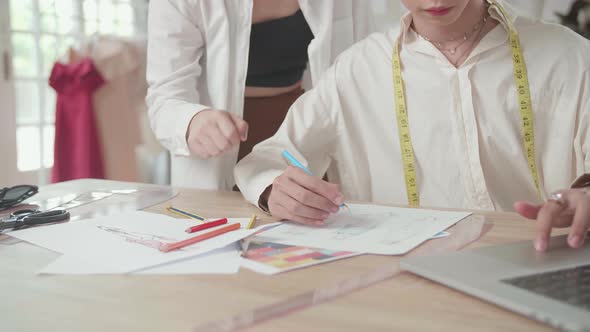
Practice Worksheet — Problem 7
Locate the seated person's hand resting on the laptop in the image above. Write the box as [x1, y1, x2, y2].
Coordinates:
[514, 188, 590, 251]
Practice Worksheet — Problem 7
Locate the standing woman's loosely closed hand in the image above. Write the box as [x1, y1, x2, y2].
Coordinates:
[186, 109, 248, 159]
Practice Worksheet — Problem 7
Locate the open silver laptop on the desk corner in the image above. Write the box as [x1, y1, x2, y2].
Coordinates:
[401, 236, 590, 331]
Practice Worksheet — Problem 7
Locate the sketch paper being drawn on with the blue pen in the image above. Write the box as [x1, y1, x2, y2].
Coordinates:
[257, 204, 470, 255]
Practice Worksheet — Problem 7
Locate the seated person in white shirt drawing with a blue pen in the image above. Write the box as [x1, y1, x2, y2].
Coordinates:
[235, 0, 590, 250]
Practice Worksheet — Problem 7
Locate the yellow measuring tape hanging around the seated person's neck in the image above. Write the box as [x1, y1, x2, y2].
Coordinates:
[392, 1, 542, 207]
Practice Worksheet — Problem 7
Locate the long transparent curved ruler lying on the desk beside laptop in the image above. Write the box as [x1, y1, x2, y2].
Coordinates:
[193, 216, 491, 332]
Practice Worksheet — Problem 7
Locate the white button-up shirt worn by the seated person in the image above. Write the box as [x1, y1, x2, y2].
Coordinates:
[235, 2, 590, 210]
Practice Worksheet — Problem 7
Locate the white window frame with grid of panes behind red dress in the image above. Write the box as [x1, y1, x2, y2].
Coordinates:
[0, 0, 148, 184]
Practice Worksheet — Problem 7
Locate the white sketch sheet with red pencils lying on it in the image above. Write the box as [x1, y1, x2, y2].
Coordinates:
[8, 211, 266, 273]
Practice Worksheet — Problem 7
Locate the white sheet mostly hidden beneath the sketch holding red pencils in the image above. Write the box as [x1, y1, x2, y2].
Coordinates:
[39, 244, 241, 275]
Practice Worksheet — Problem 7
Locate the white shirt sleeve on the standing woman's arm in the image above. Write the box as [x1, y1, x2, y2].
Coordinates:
[146, 0, 210, 156]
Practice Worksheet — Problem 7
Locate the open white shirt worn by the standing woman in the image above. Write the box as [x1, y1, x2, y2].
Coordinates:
[146, 0, 382, 190]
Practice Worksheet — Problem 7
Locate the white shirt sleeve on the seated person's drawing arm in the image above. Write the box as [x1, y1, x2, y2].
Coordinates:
[234, 66, 341, 206]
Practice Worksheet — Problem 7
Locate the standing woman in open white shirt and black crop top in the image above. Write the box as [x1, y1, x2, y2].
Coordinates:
[147, 0, 380, 190]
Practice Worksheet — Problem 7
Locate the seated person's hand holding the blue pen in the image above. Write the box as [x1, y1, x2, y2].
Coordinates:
[266, 166, 344, 225]
